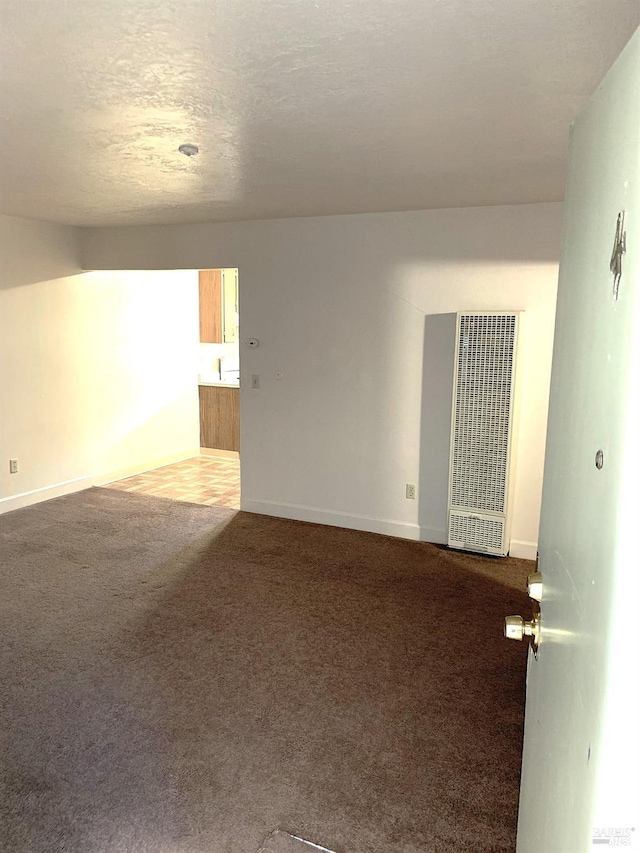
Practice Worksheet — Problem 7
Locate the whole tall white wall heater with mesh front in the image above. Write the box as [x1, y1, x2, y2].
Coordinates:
[448, 311, 519, 555]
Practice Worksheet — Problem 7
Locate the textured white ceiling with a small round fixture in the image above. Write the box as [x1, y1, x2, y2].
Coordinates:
[0, 0, 640, 225]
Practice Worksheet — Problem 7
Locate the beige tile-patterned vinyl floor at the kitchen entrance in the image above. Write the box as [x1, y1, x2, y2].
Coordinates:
[104, 456, 240, 509]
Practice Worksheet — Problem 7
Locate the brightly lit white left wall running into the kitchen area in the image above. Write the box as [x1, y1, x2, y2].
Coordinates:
[0, 216, 199, 512]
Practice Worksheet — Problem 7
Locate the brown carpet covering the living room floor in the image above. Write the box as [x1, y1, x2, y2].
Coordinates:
[0, 489, 531, 853]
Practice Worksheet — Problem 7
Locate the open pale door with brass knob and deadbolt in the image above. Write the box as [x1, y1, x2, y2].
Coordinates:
[512, 26, 640, 853]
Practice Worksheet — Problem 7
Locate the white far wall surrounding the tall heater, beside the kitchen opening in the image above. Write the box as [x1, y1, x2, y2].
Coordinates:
[83, 204, 561, 558]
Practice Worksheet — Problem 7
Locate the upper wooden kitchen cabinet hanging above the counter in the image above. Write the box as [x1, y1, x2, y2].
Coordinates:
[198, 269, 238, 344]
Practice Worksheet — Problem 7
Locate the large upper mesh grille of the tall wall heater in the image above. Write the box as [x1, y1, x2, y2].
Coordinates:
[451, 314, 516, 512]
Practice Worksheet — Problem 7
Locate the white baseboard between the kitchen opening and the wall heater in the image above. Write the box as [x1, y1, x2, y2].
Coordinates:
[240, 497, 446, 544]
